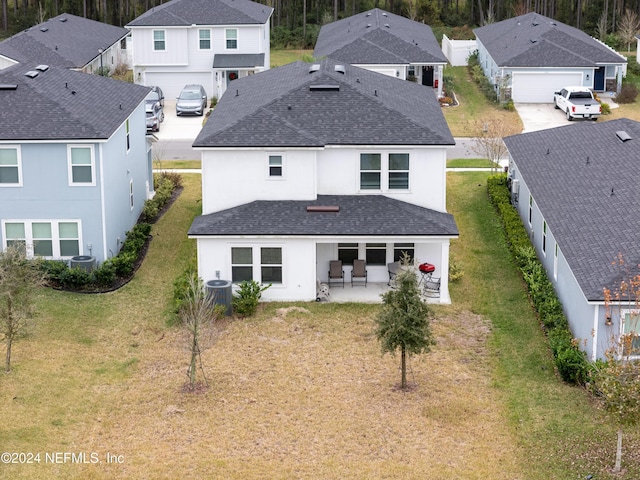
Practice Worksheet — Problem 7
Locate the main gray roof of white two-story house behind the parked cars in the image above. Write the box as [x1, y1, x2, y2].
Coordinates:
[127, 0, 273, 27]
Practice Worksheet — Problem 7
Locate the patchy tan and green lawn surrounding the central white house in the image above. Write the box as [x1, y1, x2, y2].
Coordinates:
[0, 173, 640, 480]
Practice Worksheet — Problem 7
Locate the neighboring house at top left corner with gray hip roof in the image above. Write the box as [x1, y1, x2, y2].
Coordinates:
[0, 13, 129, 73]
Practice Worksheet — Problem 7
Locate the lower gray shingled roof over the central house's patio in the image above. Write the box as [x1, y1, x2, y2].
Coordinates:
[189, 195, 458, 237]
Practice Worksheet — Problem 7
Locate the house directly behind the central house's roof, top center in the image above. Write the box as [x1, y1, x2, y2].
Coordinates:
[313, 8, 447, 97]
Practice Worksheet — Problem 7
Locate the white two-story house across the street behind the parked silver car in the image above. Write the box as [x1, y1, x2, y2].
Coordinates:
[126, 0, 273, 98]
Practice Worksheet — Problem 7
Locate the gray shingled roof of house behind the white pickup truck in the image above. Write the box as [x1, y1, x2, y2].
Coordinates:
[474, 13, 627, 67]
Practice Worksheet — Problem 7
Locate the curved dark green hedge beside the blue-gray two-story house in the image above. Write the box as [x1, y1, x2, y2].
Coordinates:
[41, 173, 182, 293]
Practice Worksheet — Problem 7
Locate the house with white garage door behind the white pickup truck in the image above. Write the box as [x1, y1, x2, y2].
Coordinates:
[474, 13, 627, 103]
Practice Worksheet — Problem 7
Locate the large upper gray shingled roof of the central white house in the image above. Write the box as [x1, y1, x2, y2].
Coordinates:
[193, 60, 455, 147]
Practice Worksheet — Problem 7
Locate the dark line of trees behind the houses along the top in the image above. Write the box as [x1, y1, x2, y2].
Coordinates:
[0, 0, 640, 48]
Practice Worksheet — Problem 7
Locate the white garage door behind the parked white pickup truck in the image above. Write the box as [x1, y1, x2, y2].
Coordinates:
[511, 72, 582, 103]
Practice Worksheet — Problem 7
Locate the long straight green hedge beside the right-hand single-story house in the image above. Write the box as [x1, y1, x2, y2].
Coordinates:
[487, 174, 590, 385]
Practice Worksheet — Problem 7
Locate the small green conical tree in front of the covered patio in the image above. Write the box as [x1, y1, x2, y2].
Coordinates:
[375, 262, 435, 389]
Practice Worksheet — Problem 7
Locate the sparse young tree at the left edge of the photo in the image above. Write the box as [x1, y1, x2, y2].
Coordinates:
[0, 246, 44, 373]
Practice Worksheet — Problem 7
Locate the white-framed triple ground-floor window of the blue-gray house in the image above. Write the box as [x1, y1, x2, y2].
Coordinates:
[2, 220, 80, 258]
